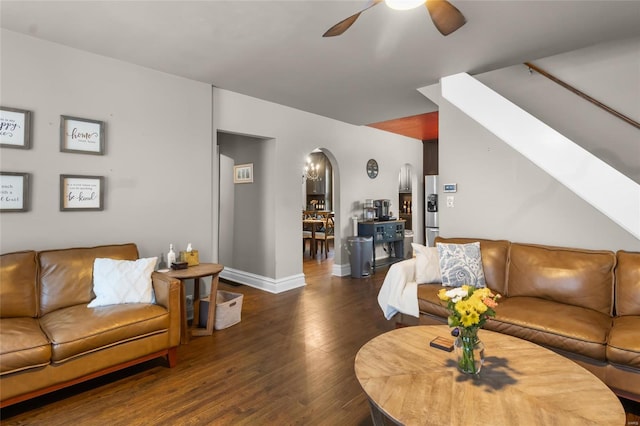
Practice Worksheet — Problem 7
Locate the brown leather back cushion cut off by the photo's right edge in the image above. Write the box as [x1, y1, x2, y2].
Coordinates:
[616, 250, 640, 315]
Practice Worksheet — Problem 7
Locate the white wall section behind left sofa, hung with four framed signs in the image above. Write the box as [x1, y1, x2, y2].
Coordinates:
[0, 30, 212, 261]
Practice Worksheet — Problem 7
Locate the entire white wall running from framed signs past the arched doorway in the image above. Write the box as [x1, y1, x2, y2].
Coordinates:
[0, 30, 423, 288]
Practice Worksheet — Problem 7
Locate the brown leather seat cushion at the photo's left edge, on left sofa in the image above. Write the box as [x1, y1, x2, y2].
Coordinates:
[0, 317, 51, 375]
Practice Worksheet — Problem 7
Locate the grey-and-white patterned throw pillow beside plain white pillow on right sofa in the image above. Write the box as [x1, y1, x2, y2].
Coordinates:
[436, 242, 486, 288]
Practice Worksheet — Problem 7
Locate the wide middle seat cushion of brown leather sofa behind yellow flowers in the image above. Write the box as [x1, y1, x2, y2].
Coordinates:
[485, 297, 611, 361]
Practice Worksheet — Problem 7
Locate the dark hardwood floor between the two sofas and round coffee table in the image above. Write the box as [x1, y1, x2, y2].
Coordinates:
[1, 251, 640, 426]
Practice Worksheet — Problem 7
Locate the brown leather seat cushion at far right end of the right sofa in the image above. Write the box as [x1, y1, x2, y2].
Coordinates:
[607, 316, 640, 369]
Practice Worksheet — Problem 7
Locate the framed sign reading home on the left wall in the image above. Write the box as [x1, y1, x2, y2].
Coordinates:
[60, 115, 105, 155]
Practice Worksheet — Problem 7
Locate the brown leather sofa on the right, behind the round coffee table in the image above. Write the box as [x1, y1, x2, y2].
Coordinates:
[410, 237, 640, 401]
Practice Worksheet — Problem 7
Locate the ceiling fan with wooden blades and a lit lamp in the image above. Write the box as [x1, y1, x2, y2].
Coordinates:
[322, 0, 467, 37]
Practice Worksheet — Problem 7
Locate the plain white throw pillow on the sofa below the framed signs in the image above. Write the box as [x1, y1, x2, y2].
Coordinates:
[87, 257, 158, 308]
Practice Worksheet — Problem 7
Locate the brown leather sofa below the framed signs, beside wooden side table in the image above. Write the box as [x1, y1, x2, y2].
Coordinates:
[0, 244, 181, 407]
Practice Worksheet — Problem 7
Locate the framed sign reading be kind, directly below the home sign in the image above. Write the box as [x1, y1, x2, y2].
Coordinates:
[60, 175, 104, 211]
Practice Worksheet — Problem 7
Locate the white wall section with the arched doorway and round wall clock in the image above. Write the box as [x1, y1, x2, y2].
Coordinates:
[214, 89, 423, 285]
